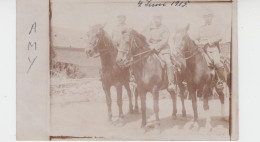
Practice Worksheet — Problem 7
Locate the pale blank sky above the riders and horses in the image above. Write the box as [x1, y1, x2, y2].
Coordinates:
[51, 0, 232, 48]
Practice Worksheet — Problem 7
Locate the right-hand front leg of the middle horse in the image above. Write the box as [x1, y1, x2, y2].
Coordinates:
[153, 87, 160, 128]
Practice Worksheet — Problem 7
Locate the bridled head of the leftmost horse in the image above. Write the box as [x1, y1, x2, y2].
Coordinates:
[85, 24, 105, 57]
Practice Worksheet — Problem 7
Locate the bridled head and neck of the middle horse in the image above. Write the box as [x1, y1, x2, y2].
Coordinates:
[116, 29, 149, 66]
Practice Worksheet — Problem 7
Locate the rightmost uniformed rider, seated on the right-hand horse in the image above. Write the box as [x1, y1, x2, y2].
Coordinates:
[195, 11, 226, 89]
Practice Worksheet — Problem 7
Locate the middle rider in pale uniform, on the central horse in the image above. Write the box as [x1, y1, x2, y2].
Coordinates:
[144, 15, 176, 91]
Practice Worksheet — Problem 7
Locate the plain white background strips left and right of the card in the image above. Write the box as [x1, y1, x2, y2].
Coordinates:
[0, 0, 260, 142]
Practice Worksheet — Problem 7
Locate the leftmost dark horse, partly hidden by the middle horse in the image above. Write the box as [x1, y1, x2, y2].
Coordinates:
[85, 24, 138, 121]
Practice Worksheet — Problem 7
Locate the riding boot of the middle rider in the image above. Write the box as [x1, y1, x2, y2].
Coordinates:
[167, 66, 177, 92]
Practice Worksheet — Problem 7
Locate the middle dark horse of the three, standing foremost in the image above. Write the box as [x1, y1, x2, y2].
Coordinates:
[117, 30, 186, 130]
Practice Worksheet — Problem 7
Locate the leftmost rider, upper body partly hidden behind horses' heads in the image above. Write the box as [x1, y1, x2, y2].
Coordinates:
[112, 15, 129, 48]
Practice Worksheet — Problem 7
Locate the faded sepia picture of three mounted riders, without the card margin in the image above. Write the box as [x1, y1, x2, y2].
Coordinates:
[49, 0, 234, 140]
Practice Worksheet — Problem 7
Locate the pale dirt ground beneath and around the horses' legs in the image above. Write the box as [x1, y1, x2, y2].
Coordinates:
[50, 78, 229, 140]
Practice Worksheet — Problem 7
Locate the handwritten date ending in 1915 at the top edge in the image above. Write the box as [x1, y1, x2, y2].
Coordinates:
[137, 0, 190, 7]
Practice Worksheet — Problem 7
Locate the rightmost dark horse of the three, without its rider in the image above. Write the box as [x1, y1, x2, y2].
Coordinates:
[174, 25, 231, 129]
